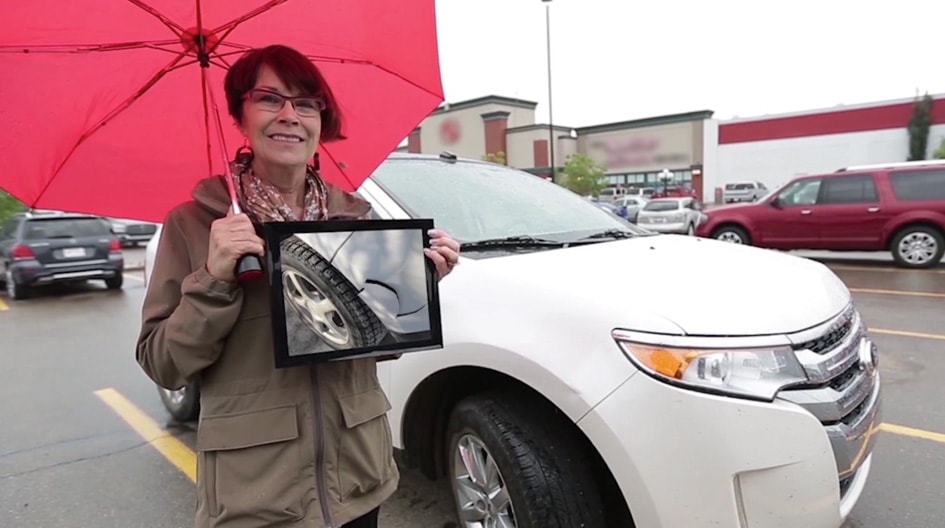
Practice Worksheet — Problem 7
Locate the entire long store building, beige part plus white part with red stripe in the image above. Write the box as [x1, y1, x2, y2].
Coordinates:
[401, 94, 945, 202]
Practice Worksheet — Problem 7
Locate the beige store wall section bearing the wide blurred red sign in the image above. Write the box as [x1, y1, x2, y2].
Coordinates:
[578, 122, 702, 173]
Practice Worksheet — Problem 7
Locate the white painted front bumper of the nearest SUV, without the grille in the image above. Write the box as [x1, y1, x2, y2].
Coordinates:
[580, 374, 871, 528]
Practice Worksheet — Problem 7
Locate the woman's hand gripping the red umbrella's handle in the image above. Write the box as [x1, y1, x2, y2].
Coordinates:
[207, 211, 265, 282]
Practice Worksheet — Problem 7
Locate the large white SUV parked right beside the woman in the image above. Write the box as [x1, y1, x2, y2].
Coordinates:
[147, 153, 881, 528]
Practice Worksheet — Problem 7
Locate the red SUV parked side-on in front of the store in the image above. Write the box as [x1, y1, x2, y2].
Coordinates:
[696, 160, 945, 268]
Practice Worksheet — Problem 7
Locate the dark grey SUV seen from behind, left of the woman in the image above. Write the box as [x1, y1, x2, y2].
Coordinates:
[0, 211, 125, 300]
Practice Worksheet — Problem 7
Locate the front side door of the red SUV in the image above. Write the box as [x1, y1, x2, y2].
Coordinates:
[752, 178, 822, 250]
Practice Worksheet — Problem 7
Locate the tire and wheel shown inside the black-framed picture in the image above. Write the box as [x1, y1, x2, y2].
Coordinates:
[281, 237, 387, 350]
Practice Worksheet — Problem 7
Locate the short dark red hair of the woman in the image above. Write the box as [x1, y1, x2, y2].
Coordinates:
[223, 44, 344, 142]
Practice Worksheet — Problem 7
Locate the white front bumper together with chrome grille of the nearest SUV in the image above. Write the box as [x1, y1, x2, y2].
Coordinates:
[579, 307, 882, 528]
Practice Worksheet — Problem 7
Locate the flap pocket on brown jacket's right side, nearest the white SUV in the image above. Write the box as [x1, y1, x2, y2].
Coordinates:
[338, 387, 393, 502]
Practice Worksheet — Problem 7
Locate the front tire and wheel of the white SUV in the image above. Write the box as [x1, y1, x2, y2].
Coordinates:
[446, 390, 607, 528]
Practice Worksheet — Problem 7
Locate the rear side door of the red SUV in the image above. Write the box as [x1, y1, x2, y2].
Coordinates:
[811, 174, 892, 250]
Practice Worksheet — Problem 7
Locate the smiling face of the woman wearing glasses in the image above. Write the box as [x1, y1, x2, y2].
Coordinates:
[240, 64, 323, 168]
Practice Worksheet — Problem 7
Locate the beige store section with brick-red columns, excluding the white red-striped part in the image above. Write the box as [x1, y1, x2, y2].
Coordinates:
[401, 95, 717, 200]
